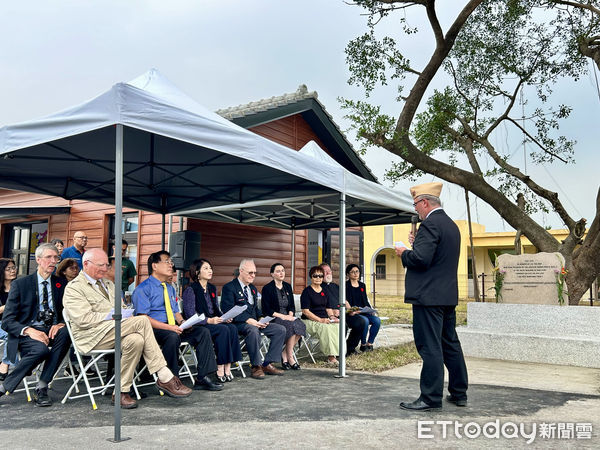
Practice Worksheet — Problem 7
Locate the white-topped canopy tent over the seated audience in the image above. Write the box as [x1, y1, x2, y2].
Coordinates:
[0, 70, 412, 440]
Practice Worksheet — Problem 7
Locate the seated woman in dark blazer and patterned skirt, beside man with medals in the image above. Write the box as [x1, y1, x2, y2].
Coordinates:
[261, 263, 306, 370]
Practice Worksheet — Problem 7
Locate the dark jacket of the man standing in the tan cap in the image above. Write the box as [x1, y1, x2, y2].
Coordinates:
[402, 209, 460, 306]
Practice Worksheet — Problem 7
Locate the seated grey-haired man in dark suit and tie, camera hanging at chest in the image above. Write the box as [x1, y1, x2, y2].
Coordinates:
[0, 244, 71, 406]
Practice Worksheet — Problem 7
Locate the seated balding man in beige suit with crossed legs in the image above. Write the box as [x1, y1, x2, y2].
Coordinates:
[63, 248, 192, 409]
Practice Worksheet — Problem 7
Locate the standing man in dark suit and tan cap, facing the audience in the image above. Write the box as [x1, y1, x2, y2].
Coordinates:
[396, 183, 468, 411]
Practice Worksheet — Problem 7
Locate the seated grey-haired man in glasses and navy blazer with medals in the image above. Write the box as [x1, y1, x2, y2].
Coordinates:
[221, 259, 285, 380]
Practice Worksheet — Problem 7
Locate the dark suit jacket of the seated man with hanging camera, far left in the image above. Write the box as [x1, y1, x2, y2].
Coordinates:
[2, 272, 67, 361]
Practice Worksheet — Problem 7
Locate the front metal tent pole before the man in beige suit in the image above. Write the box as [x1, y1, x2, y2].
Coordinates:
[109, 124, 127, 442]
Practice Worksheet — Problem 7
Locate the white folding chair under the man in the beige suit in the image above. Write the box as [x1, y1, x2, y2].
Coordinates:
[61, 310, 116, 410]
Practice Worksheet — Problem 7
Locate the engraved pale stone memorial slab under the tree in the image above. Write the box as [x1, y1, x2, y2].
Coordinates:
[495, 253, 569, 305]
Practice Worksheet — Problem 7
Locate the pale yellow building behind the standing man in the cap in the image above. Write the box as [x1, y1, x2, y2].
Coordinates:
[363, 220, 568, 299]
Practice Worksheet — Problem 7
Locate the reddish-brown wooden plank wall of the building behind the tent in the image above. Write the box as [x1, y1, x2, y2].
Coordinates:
[0, 114, 340, 293]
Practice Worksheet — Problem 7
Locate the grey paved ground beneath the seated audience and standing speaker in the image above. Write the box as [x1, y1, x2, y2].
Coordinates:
[0, 330, 600, 449]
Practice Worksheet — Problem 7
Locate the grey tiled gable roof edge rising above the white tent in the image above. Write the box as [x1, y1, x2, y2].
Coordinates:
[216, 84, 377, 180]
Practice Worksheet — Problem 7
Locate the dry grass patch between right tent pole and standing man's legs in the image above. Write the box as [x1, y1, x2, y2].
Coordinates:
[302, 342, 421, 373]
